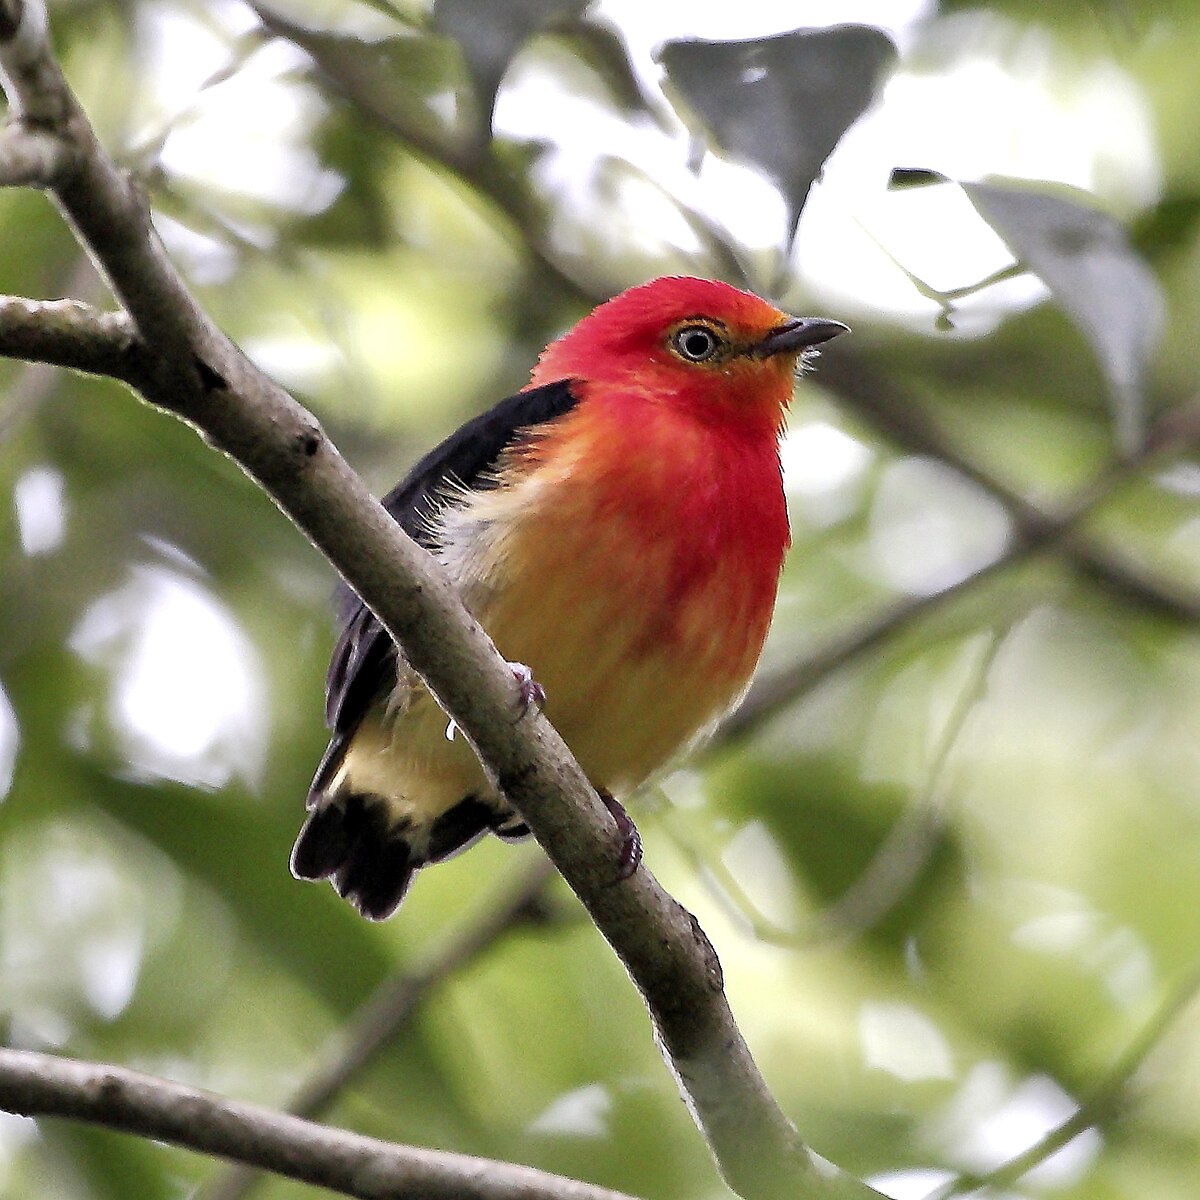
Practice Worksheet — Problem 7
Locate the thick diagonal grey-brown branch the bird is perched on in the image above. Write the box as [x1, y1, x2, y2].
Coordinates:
[0, 0, 876, 1198]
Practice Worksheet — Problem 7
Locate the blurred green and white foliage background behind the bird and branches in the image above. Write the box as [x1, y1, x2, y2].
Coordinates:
[0, 0, 1200, 1200]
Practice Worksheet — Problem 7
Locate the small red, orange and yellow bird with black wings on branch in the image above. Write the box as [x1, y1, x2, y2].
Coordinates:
[290, 276, 847, 920]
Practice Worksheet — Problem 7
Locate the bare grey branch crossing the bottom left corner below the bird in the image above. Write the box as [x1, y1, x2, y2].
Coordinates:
[0, 1049, 631, 1200]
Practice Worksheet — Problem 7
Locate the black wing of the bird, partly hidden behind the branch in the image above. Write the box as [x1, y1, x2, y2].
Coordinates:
[313, 379, 577, 748]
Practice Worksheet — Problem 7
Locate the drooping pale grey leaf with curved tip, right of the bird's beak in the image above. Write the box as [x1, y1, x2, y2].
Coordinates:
[962, 182, 1163, 452]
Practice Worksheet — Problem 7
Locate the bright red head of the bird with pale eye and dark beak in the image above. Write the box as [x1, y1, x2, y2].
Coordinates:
[533, 276, 846, 428]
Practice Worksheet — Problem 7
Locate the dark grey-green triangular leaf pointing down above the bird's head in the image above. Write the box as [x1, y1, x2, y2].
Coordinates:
[659, 25, 895, 238]
